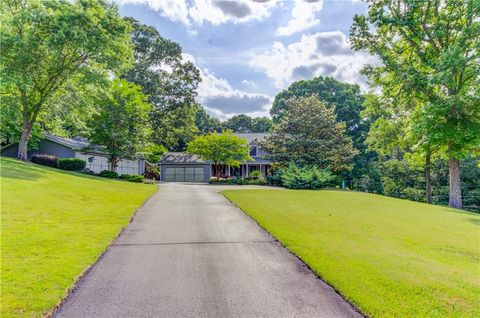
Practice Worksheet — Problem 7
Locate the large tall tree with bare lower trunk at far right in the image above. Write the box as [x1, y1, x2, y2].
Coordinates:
[351, 0, 480, 208]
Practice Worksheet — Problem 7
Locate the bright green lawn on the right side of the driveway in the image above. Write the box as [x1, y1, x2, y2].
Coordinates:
[223, 190, 480, 317]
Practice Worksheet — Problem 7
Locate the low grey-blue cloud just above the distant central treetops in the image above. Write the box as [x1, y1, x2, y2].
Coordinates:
[183, 53, 273, 119]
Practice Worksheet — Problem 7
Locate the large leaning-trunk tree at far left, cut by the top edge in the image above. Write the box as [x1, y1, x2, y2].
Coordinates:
[0, 0, 131, 160]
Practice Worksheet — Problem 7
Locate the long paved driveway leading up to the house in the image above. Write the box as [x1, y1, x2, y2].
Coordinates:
[55, 183, 362, 318]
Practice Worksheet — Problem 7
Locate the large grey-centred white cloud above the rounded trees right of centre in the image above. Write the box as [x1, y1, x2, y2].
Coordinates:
[250, 31, 374, 88]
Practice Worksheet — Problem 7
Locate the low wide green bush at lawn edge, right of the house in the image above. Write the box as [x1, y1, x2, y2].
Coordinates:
[279, 163, 336, 189]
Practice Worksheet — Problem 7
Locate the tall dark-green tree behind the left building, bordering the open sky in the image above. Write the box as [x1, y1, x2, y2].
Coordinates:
[124, 18, 201, 150]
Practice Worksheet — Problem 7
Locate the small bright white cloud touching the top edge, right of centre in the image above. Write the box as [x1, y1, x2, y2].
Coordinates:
[277, 0, 323, 35]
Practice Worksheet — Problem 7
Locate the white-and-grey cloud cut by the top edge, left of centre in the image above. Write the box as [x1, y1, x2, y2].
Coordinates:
[114, 0, 277, 27]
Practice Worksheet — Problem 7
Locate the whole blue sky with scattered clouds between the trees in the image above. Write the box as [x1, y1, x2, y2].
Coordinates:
[114, 0, 373, 119]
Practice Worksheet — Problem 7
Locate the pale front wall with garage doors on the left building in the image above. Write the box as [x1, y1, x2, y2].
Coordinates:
[75, 152, 145, 174]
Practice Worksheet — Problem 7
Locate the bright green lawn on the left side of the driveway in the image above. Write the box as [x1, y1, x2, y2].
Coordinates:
[0, 158, 157, 317]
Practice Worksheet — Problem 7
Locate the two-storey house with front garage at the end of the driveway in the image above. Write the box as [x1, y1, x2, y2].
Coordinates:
[159, 133, 270, 182]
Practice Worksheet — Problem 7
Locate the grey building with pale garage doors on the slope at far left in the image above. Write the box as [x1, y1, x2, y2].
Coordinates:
[1, 133, 145, 175]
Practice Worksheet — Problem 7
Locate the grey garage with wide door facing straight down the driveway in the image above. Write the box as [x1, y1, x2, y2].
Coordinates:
[159, 152, 211, 183]
